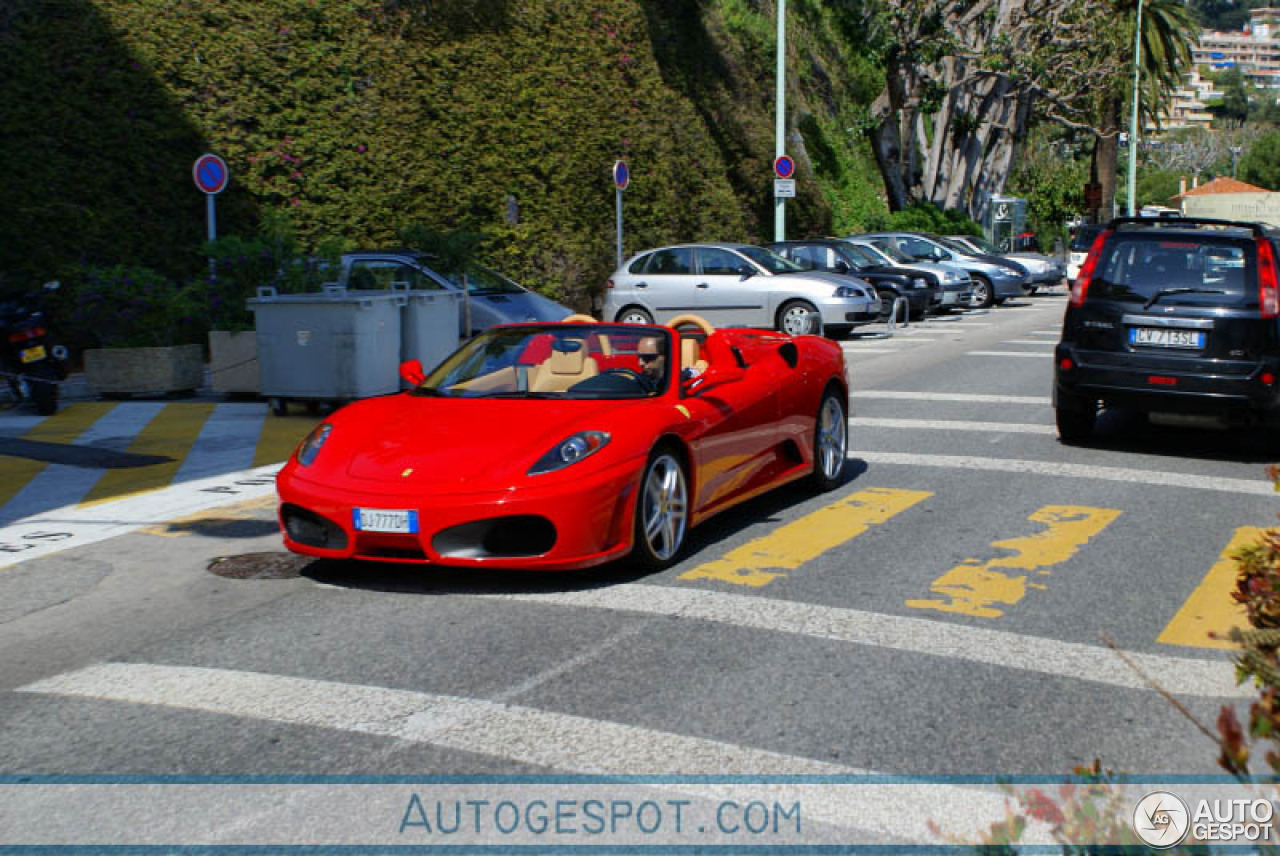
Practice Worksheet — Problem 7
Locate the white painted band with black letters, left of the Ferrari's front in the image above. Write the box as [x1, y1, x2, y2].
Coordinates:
[0, 464, 279, 568]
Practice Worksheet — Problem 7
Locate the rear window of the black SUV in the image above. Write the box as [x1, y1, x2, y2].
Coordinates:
[1088, 232, 1257, 306]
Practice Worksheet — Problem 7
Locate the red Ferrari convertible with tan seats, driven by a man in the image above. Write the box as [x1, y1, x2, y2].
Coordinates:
[276, 315, 849, 571]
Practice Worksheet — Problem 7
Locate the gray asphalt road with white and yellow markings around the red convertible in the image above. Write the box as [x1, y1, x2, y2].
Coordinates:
[0, 294, 1275, 839]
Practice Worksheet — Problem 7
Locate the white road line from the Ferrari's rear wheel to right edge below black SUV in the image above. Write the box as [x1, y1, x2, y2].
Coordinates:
[849, 449, 1276, 496]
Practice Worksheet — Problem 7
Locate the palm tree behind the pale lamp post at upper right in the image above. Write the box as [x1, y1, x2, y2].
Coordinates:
[1091, 0, 1199, 220]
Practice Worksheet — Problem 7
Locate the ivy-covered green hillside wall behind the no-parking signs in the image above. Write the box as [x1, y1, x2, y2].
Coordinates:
[0, 0, 884, 307]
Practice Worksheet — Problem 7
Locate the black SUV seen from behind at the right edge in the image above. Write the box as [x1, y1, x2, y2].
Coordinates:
[1053, 218, 1280, 443]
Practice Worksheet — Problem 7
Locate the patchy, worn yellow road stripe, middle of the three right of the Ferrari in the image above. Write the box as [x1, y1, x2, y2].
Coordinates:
[906, 505, 1120, 618]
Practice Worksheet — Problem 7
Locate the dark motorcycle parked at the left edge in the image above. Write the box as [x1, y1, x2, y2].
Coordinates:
[0, 281, 67, 416]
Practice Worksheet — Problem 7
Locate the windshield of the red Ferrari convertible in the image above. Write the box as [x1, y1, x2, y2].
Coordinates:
[412, 324, 671, 399]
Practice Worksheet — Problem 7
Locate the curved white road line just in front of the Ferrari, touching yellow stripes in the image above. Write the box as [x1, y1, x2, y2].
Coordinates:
[491, 583, 1256, 699]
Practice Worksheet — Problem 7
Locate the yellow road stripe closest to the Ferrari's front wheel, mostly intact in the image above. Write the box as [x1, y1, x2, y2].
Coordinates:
[680, 487, 933, 587]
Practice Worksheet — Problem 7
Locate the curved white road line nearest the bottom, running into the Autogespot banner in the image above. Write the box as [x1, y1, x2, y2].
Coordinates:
[18, 663, 1052, 850]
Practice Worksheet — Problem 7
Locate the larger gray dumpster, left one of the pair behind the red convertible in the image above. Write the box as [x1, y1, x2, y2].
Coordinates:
[248, 287, 406, 416]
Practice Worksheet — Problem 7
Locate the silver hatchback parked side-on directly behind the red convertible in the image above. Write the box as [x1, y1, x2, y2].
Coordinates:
[602, 243, 881, 337]
